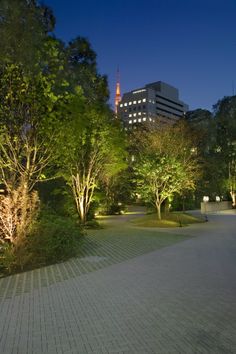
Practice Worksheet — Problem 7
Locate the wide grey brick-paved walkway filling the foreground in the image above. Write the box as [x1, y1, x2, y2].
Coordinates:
[0, 213, 236, 354]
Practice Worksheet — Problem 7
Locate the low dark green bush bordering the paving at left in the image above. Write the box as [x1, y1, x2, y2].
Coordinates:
[0, 213, 83, 274]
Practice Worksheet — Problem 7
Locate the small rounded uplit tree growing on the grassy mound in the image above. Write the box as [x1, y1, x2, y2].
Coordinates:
[134, 122, 199, 219]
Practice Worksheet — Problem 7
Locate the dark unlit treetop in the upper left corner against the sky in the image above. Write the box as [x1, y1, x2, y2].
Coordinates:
[0, 0, 55, 71]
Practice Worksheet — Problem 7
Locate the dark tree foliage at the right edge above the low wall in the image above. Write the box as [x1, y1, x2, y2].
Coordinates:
[198, 96, 236, 202]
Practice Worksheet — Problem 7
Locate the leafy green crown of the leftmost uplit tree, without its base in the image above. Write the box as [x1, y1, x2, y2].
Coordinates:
[0, 64, 63, 196]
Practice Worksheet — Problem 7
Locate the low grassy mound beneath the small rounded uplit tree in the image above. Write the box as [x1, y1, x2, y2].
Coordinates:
[131, 212, 204, 228]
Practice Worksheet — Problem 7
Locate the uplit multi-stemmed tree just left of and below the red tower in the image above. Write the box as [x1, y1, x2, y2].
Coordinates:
[58, 90, 125, 224]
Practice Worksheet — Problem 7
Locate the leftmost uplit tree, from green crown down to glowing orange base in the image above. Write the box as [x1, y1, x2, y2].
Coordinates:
[0, 64, 62, 243]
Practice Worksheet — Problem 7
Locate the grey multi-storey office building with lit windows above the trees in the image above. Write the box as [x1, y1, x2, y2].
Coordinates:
[117, 81, 188, 127]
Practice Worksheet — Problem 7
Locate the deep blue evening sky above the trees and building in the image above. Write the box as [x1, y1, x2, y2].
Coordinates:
[44, 0, 236, 110]
